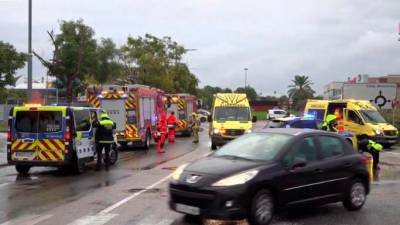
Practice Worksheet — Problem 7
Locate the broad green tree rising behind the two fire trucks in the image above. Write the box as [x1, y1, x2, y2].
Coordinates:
[119, 34, 199, 94]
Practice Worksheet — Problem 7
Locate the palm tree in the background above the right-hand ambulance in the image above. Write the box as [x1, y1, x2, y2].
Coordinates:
[287, 75, 315, 98]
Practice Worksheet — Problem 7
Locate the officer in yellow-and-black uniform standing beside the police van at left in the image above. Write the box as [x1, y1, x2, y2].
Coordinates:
[94, 113, 116, 171]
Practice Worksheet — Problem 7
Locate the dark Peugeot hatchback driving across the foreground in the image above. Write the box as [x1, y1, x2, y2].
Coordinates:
[169, 128, 370, 225]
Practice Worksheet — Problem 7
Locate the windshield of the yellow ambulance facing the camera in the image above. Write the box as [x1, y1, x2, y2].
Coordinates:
[215, 107, 250, 121]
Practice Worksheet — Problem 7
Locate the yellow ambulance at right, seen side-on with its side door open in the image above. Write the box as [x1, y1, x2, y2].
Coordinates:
[304, 99, 398, 147]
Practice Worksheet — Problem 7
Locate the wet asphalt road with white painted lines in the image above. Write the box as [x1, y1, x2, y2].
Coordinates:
[0, 124, 400, 225]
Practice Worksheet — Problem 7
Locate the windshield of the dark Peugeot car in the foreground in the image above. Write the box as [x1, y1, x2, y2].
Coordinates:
[214, 133, 291, 161]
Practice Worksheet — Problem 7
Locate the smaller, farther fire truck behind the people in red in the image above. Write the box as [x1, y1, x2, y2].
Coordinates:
[164, 93, 197, 136]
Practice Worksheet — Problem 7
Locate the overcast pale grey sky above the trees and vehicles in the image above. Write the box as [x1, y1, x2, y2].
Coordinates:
[0, 0, 400, 95]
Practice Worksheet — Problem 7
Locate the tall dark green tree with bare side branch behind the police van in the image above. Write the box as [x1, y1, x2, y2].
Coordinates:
[34, 20, 98, 102]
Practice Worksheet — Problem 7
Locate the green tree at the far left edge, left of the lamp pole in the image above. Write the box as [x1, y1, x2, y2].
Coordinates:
[0, 41, 26, 93]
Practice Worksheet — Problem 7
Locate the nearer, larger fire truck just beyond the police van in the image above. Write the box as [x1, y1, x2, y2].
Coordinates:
[86, 85, 165, 149]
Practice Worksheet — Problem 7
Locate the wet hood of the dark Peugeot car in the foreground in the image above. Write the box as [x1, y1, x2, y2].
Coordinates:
[185, 156, 262, 176]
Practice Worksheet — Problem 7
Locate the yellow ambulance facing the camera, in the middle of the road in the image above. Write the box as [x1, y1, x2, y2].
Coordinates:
[208, 93, 257, 150]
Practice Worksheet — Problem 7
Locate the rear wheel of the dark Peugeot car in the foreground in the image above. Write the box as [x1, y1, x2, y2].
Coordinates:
[343, 179, 367, 211]
